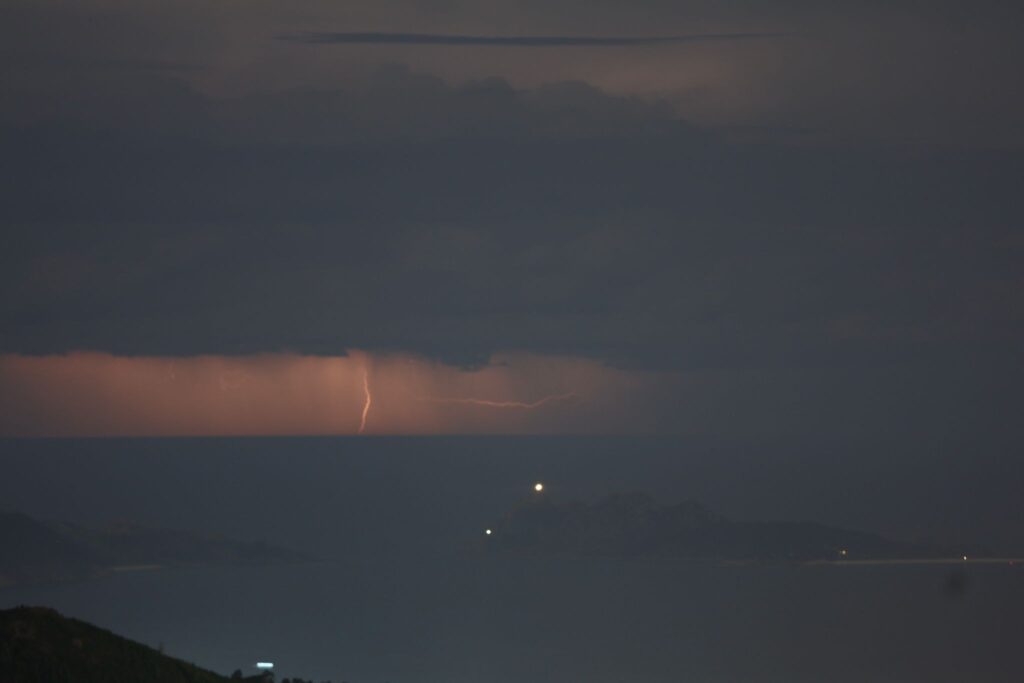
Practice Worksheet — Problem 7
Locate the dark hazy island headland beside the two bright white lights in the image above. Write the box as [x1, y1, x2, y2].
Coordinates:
[486, 494, 974, 561]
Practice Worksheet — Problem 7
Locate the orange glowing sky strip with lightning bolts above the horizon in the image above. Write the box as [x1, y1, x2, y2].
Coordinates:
[0, 351, 646, 436]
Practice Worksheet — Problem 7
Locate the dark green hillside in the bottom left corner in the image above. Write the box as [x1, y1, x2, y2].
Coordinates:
[0, 607, 246, 683]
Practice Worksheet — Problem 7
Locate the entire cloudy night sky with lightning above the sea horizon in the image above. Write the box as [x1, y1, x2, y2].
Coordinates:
[0, 0, 1024, 438]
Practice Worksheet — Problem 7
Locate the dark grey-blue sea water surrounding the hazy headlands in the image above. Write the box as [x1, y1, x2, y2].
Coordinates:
[0, 437, 1024, 683]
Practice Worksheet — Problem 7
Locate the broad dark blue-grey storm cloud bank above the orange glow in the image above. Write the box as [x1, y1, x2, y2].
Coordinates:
[3, 69, 1021, 367]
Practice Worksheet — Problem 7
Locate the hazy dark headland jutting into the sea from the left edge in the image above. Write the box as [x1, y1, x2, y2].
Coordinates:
[0, 512, 309, 587]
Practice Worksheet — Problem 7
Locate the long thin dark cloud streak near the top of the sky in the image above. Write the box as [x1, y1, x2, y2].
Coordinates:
[279, 31, 783, 47]
